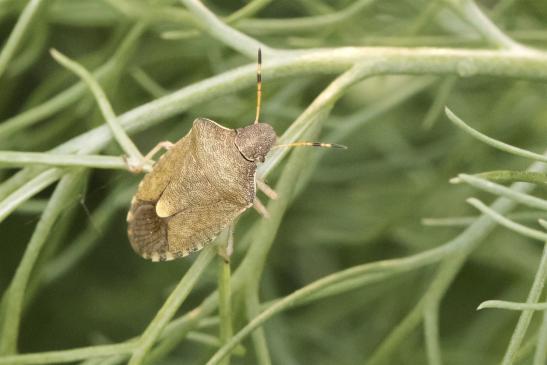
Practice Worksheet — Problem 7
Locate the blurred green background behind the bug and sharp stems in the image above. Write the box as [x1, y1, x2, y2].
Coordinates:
[0, 0, 547, 365]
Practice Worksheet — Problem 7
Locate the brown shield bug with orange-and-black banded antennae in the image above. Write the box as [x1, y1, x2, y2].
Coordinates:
[127, 49, 344, 261]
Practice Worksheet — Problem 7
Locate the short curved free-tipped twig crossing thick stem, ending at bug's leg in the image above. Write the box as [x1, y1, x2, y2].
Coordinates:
[51, 49, 145, 166]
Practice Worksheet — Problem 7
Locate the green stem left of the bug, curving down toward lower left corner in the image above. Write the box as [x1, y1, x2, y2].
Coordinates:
[0, 172, 83, 355]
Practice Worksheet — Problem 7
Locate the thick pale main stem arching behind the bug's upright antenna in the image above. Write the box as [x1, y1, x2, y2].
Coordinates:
[48, 47, 547, 161]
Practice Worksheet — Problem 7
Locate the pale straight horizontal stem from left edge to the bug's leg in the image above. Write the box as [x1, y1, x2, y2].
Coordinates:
[0, 151, 128, 171]
